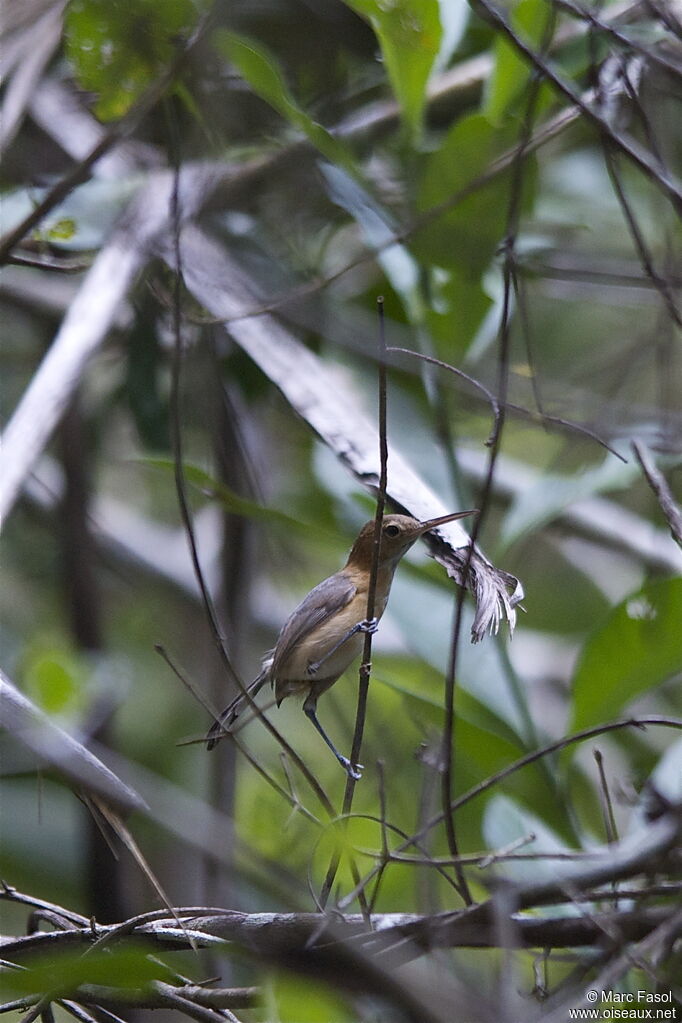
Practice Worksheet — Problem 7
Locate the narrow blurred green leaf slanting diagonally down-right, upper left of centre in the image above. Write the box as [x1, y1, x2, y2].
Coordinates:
[214, 29, 354, 171]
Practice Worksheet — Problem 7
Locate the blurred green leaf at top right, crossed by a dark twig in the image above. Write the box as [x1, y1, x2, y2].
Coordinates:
[484, 0, 551, 125]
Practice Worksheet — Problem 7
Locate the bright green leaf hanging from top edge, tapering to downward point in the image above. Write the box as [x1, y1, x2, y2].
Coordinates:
[346, 0, 443, 140]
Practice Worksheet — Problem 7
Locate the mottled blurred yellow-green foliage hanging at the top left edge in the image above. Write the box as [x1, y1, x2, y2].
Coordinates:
[65, 0, 205, 121]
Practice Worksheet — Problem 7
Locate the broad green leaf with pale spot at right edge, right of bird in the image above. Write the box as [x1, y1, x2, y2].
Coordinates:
[571, 579, 682, 731]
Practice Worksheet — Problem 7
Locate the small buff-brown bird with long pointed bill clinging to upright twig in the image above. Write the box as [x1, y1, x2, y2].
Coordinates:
[207, 510, 475, 781]
